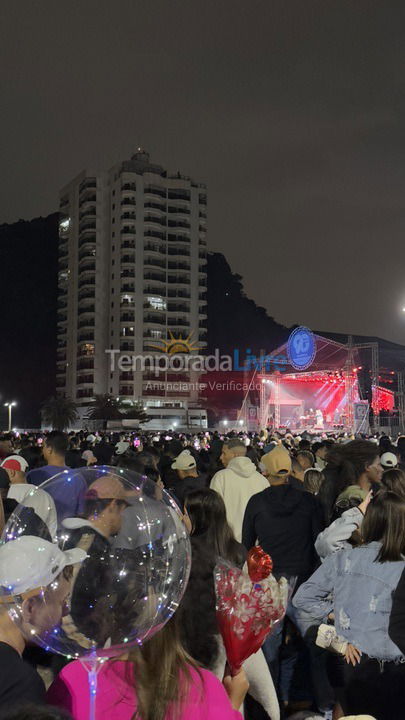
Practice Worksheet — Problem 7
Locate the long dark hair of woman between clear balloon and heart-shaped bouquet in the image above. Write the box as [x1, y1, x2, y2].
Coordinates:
[185, 488, 245, 565]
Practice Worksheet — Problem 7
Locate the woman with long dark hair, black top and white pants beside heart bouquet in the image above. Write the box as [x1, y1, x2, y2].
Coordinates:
[178, 488, 280, 720]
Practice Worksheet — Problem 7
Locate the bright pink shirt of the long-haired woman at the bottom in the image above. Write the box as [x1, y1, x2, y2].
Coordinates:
[47, 660, 242, 720]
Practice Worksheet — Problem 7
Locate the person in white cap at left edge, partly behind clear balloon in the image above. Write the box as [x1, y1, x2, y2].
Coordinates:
[0, 535, 86, 710]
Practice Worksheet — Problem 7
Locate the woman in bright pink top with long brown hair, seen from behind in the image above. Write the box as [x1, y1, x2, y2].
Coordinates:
[47, 613, 248, 720]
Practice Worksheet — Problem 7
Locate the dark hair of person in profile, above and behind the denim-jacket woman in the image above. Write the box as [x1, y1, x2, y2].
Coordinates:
[326, 440, 379, 495]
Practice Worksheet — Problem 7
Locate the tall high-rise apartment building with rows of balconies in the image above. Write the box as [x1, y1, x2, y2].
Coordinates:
[57, 148, 207, 427]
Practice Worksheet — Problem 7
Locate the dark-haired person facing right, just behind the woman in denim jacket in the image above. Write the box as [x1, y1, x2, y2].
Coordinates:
[318, 440, 382, 525]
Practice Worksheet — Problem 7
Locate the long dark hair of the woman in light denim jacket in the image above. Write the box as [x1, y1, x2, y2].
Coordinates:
[361, 490, 405, 562]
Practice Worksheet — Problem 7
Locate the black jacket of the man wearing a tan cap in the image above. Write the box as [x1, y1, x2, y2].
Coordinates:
[242, 484, 323, 582]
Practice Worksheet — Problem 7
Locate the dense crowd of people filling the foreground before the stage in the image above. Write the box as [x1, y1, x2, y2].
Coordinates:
[0, 430, 405, 720]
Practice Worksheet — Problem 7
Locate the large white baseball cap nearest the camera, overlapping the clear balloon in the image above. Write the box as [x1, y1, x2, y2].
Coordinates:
[0, 535, 87, 602]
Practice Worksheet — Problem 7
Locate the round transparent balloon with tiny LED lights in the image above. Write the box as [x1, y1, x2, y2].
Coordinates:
[0, 466, 191, 660]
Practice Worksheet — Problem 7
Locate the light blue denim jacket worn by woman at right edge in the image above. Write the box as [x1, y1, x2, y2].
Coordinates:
[293, 542, 405, 661]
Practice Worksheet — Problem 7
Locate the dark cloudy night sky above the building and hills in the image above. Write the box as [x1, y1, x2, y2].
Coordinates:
[0, 0, 405, 343]
